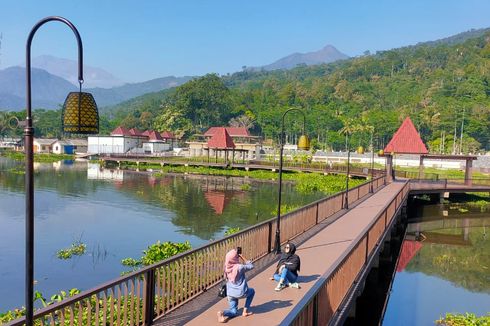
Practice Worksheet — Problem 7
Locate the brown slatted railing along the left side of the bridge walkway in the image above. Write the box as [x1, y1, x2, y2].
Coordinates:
[7, 176, 386, 326]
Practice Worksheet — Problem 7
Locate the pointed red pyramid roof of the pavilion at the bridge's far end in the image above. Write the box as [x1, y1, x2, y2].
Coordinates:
[384, 117, 429, 154]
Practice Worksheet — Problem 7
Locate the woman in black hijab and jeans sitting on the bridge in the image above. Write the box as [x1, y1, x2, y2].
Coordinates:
[273, 242, 301, 291]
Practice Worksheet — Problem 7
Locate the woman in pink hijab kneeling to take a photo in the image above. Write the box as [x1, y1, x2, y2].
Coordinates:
[218, 249, 255, 323]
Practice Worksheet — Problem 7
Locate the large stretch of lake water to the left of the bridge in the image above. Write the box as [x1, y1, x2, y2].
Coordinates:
[0, 157, 324, 312]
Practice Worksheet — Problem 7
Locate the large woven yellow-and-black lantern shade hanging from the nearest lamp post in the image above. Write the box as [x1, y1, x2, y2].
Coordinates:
[61, 92, 99, 134]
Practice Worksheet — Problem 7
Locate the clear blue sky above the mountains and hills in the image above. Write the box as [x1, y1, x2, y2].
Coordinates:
[0, 0, 490, 82]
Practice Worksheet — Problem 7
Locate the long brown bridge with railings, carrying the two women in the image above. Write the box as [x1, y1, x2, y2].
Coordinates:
[7, 176, 490, 325]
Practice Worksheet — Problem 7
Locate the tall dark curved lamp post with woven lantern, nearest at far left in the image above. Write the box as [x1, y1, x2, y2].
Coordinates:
[24, 16, 99, 326]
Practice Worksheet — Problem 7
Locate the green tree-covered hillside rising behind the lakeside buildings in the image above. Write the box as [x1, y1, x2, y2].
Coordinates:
[1, 32, 490, 153]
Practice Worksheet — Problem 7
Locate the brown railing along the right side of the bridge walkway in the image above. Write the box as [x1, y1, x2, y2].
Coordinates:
[281, 181, 410, 326]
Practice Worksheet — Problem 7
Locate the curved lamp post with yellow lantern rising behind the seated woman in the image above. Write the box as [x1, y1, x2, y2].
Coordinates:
[274, 108, 310, 254]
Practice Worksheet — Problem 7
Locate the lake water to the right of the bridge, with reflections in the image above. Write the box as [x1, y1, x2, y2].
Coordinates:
[383, 197, 490, 325]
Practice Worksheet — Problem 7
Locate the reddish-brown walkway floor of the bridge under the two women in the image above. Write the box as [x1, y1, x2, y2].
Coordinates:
[155, 182, 404, 326]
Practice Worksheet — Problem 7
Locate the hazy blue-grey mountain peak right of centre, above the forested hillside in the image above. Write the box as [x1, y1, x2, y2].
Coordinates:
[249, 45, 349, 71]
